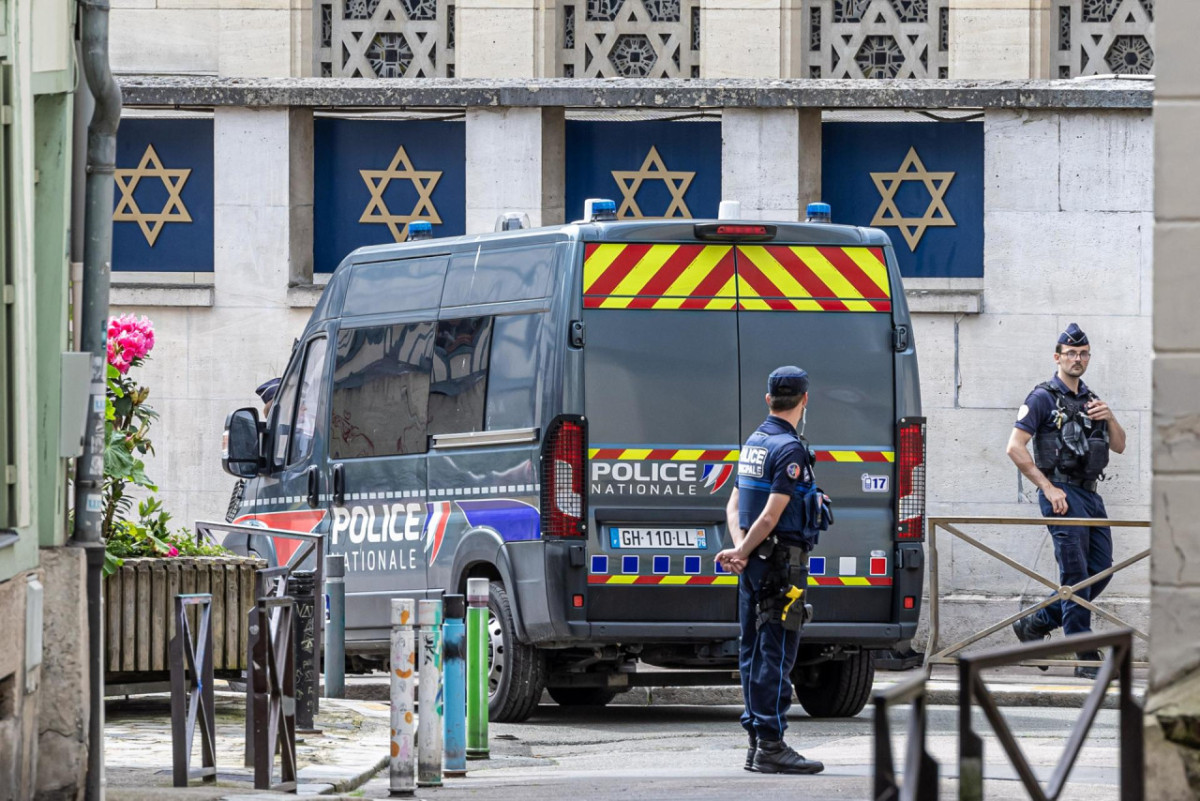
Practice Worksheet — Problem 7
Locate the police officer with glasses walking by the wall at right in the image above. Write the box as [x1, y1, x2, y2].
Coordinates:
[1008, 323, 1126, 679]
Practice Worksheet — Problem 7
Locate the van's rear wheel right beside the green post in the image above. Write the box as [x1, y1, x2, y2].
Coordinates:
[487, 582, 546, 723]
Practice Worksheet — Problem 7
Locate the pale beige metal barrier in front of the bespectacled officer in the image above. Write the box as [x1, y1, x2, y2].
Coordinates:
[925, 517, 1150, 667]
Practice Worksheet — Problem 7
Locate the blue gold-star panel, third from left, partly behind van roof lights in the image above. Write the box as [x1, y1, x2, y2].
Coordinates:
[566, 120, 721, 221]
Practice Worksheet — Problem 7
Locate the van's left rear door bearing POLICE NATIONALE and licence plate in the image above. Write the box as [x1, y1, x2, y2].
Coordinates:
[583, 243, 740, 622]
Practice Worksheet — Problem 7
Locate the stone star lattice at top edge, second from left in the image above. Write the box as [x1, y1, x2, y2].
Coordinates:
[558, 0, 700, 78]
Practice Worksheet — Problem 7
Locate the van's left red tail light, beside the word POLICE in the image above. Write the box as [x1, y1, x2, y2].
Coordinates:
[541, 415, 588, 537]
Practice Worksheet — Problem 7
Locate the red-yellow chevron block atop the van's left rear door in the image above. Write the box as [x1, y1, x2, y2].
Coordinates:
[583, 243, 737, 311]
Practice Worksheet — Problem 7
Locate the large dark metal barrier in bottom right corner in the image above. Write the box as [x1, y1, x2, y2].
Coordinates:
[955, 630, 1145, 801]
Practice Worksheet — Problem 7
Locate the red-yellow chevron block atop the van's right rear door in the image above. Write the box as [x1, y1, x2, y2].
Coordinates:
[737, 245, 892, 312]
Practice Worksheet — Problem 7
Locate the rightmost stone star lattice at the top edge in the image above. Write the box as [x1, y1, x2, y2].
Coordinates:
[1054, 0, 1154, 78]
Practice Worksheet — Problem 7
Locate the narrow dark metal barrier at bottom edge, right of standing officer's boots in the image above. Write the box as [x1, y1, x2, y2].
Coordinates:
[871, 668, 938, 801]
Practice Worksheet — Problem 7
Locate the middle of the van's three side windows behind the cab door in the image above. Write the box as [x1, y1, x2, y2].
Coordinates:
[430, 317, 492, 434]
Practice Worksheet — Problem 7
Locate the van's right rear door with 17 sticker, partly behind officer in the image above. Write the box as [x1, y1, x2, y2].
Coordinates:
[736, 243, 896, 622]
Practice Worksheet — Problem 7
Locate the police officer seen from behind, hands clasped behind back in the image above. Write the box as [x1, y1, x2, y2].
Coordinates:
[716, 367, 828, 773]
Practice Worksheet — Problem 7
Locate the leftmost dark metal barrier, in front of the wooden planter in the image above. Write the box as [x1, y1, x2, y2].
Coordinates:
[169, 594, 217, 787]
